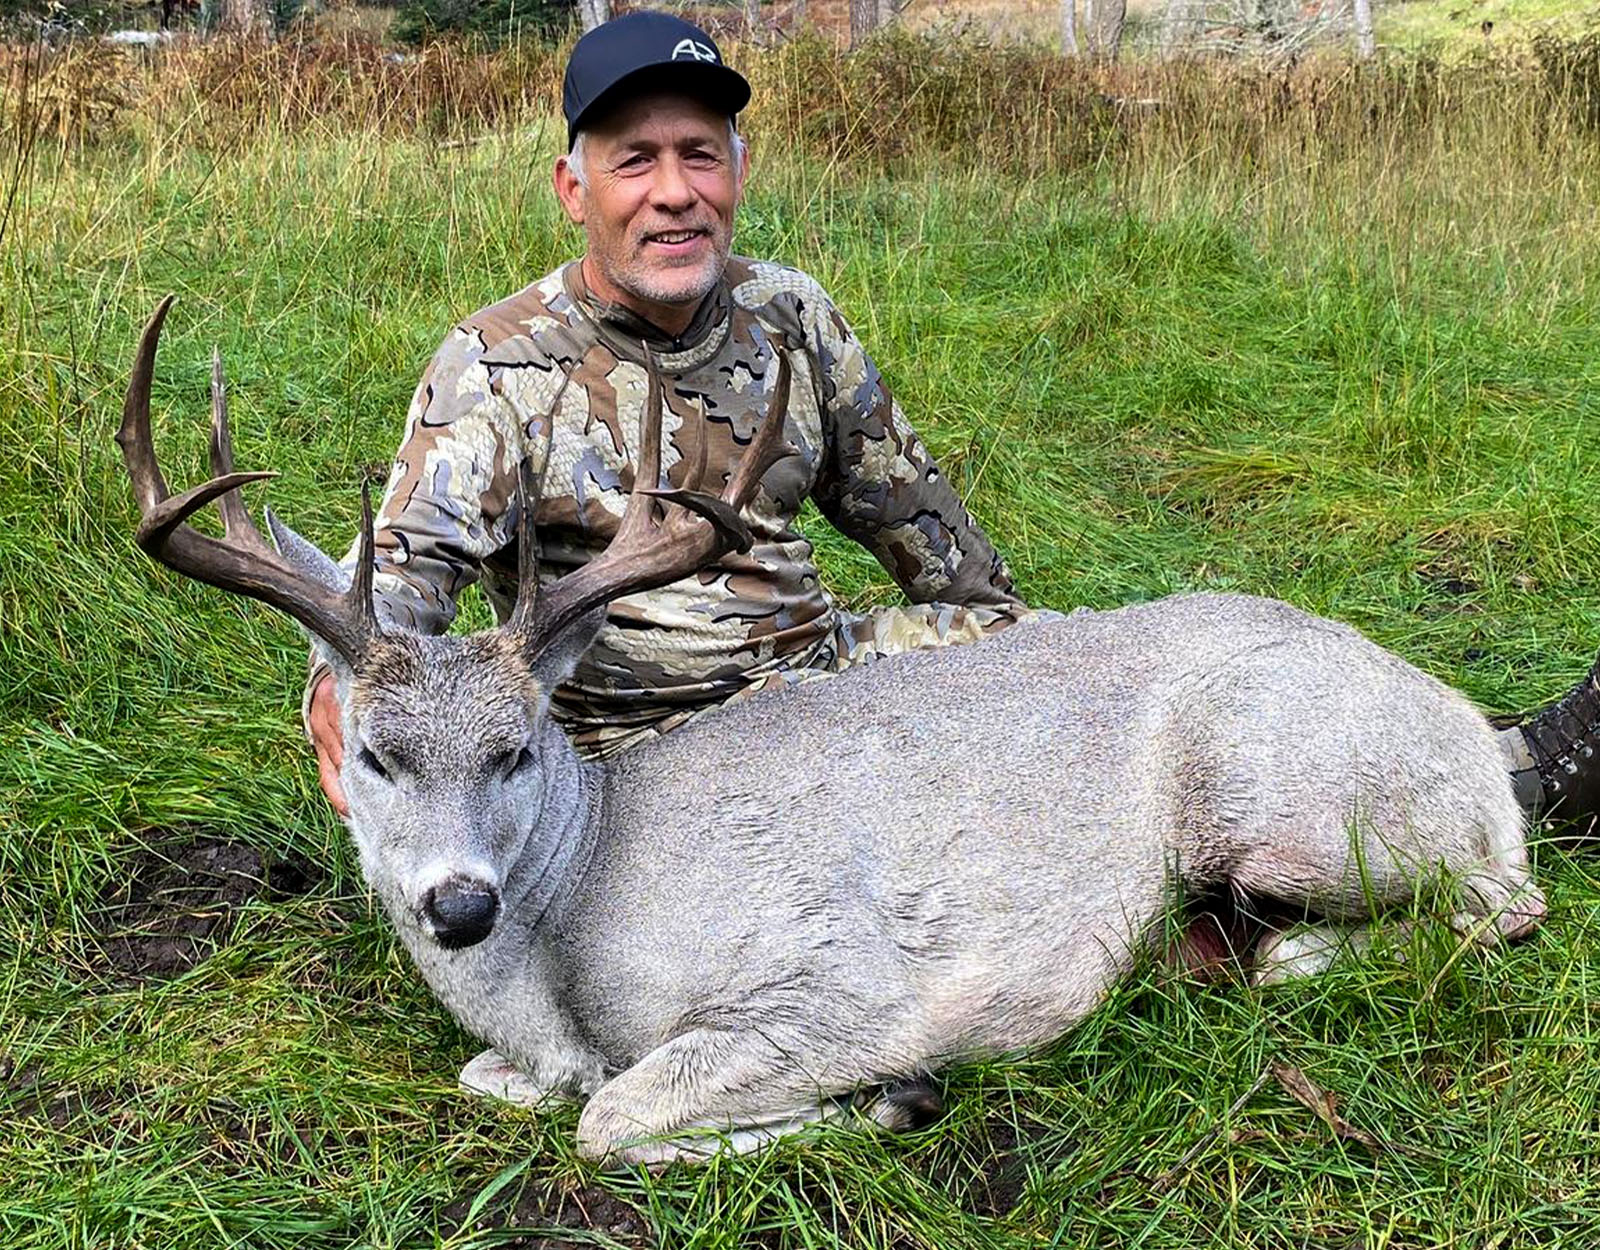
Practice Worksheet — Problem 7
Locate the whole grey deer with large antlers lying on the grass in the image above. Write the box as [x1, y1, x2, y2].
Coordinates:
[117, 296, 1546, 1165]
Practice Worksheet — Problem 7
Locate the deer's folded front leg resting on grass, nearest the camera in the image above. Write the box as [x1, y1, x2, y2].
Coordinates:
[578, 1029, 851, 1164]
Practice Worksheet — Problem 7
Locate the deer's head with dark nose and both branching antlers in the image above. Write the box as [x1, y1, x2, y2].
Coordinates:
[117, 296, 789, 949]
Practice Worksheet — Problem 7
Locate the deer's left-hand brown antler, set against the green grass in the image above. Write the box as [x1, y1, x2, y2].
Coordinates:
[117, 296, 381, 666]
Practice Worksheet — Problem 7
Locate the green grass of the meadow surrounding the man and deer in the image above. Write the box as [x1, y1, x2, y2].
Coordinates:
[9, 34, 1600, 1248]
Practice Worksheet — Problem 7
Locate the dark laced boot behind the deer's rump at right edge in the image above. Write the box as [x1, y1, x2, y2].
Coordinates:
[1501, 658, 1600, 826]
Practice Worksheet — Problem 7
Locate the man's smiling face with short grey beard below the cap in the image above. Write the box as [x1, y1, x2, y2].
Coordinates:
[555, 94, 747, 333]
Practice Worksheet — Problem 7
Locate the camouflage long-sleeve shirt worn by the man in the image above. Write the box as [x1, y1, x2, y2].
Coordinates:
[344, 258, 1021, 743]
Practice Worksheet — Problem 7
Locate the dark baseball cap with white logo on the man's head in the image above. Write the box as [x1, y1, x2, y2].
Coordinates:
[562, 11, 750, 149]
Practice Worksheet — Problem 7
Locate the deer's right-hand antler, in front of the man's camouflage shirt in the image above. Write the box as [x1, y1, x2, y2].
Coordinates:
[507, 340, 790, 653]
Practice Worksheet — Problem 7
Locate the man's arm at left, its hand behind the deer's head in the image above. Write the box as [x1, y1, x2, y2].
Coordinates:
[301, 328, 523, 816]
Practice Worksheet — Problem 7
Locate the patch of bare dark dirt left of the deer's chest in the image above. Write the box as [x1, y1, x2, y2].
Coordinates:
[98, 834, 322, 981]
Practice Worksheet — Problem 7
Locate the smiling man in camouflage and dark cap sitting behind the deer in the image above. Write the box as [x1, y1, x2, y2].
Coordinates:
[306, 13, 1600, 815]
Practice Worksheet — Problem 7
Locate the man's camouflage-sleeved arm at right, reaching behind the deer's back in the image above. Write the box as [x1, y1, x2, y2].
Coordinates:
[814, 306, 1022, 608]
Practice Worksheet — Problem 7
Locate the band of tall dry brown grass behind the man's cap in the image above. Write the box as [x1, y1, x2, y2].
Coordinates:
[0, 27, 1600, 171]
